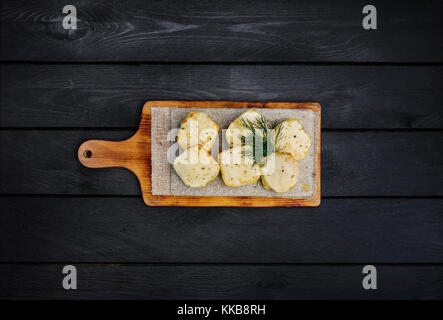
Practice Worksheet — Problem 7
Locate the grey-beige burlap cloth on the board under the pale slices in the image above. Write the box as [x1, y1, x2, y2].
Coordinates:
[151, 107, 320, 199]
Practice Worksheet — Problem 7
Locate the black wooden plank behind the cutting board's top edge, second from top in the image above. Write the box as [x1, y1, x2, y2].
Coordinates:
[0, 64, 443, 129]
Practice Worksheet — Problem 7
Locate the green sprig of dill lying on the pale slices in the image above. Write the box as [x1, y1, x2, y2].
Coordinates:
[240, 116, 283, 166]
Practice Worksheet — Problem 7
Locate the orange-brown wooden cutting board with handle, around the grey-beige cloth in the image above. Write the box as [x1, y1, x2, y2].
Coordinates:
[78, 101, 321, 207]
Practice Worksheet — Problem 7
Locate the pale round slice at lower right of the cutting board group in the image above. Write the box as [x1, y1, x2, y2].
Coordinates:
[262, 152, 299, 193]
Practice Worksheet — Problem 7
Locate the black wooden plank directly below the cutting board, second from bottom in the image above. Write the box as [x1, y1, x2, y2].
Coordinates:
[0, 197, 443, 263]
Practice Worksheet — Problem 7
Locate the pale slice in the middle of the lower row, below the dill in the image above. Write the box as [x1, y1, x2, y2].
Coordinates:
[218, 147, 260, 187]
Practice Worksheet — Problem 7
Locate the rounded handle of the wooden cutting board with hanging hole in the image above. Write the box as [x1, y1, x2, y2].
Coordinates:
[78, 138, 134, 170]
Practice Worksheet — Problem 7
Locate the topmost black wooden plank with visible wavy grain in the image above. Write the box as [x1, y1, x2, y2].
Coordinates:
[1, 0, 443, 62]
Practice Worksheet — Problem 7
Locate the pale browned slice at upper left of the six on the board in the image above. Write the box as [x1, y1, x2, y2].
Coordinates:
[177, 111, 219, 150]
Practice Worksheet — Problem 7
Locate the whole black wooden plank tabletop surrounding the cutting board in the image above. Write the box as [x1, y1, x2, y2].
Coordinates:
[0, 0, 443, 299]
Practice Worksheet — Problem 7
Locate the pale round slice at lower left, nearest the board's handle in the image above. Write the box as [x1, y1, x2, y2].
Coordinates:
[173, 146, 220, 188]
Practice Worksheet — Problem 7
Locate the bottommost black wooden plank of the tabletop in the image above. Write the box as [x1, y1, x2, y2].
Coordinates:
[0, 265, 443, 300]
